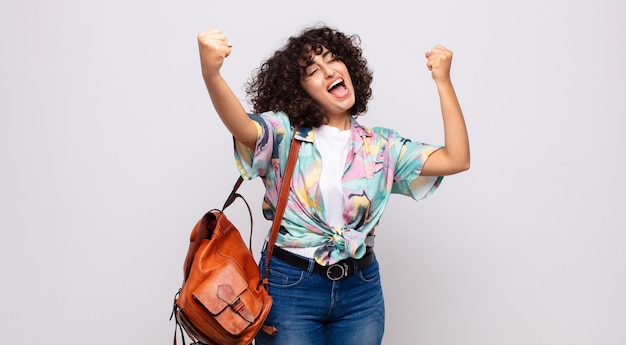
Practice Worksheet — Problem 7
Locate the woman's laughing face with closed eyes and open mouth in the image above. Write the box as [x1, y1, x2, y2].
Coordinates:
[300, 47, 355, 117]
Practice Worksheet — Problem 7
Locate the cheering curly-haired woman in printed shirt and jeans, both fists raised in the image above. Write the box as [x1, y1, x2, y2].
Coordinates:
[198, 27, 470, 345]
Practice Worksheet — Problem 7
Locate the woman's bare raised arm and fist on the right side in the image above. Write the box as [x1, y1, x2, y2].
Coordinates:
[421, 46, 470, 176]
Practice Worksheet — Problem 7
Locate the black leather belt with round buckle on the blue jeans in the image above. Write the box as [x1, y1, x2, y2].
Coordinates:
[272, 246, 374, 280]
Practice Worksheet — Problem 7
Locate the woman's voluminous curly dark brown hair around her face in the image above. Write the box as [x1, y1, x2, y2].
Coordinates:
[246, 26, 373, 127]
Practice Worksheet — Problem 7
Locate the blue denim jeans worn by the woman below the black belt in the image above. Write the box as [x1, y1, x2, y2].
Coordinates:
[255, 252, 385, 345]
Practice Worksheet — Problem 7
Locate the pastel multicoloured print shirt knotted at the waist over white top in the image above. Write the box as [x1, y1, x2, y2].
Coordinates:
[235, 112, 443, 265]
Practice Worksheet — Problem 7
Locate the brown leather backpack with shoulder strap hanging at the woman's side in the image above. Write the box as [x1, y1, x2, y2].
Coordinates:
[170, 131, 300, 345]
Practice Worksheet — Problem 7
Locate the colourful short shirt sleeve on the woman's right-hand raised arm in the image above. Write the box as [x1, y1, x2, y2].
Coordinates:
[391, 132, 443, 200]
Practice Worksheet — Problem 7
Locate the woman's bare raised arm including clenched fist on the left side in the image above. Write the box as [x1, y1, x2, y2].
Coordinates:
[198, 29, 257, 149]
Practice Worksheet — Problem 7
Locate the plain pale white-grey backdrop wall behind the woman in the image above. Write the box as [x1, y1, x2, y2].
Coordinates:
[0, 0, 626, 345]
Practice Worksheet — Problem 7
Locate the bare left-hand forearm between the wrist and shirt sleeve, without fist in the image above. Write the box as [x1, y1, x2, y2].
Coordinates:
[203, 73, 257, 148]
